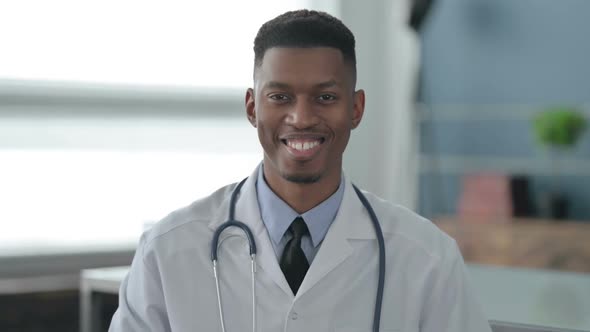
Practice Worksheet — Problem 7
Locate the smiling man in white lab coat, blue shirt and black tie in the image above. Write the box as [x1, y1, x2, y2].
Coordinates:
[109, 10, 490, 332]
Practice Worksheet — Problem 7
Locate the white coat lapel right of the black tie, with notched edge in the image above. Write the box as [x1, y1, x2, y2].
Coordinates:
[296, 181, 376, 298]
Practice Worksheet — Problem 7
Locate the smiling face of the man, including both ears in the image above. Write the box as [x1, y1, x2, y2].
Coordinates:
[246, 47, 364, 187]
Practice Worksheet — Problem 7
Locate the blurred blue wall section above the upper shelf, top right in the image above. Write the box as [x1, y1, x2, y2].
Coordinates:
[422, 0, 590, 104]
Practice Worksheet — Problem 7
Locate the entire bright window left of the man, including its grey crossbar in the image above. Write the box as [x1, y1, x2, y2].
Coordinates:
[0, 0, 338, 249]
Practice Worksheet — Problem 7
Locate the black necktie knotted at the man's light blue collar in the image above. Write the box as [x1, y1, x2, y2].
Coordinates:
[280, 217, 309, 294]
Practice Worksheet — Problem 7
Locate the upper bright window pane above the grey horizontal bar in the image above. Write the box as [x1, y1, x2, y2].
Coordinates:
[0, 0, 320, 88]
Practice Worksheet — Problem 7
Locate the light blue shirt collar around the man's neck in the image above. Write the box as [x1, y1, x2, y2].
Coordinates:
[256, 164, 344, 247]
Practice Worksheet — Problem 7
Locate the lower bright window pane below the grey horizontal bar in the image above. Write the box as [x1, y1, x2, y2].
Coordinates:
[0, 118, 261, 247]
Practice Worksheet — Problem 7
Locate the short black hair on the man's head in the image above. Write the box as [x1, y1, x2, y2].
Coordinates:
[254, 9, 356, 73]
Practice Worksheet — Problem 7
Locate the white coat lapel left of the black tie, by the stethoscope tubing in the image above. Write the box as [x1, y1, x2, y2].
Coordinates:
[209, 166, 293, 295]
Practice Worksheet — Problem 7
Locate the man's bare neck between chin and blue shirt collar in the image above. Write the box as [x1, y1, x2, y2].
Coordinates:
[263, 165, 342, 213]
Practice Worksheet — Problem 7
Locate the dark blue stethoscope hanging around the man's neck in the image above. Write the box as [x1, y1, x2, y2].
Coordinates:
[211, 178, 385, 332]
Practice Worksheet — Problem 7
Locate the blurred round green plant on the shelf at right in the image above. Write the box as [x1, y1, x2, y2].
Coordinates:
[533, 107, 588, 148]
